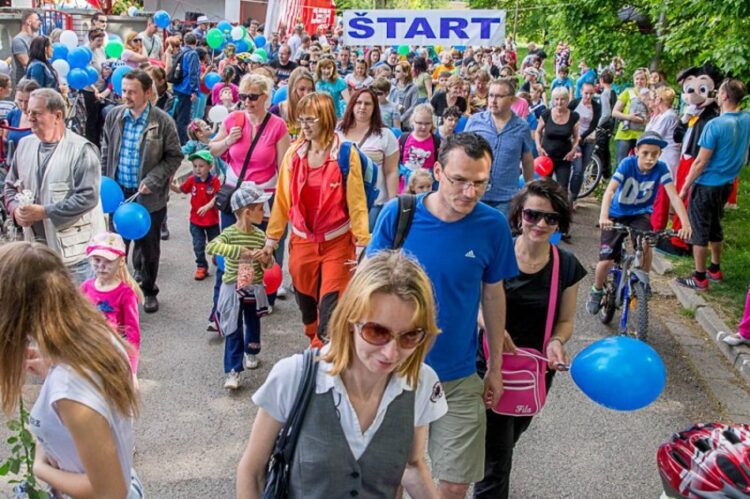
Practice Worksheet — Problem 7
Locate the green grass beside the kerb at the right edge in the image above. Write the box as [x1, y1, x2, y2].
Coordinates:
[672, 166, 750, 328]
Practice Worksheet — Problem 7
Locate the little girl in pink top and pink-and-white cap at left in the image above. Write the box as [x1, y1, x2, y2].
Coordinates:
[81, 232, 143, 387]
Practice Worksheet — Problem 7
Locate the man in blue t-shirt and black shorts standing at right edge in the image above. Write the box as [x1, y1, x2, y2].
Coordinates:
[677, 78, 750, 291]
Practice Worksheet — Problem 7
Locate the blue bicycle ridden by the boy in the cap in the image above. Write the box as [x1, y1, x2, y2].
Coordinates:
[598, 224, 677, 341]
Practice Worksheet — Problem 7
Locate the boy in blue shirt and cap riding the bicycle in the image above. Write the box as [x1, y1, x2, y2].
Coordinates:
[586, 131, 691, 315]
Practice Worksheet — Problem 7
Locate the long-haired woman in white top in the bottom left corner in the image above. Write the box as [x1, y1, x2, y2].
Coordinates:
[0, 242, 143, 498]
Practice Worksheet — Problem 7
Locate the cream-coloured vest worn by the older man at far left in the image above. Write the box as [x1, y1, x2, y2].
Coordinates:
[16, 130, 107, 266]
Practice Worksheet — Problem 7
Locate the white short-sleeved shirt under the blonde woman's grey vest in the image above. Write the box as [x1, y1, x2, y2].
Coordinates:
[253, 346, 448, 459]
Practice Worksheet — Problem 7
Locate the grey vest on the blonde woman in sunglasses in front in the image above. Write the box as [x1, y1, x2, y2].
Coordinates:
[289, 389, 414, 499]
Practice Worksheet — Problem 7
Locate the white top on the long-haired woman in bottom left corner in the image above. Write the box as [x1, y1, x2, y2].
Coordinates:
[29, 364, 133, 484]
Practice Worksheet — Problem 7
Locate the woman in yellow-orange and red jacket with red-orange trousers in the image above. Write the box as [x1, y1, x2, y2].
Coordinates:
[264, 92, 370, 346]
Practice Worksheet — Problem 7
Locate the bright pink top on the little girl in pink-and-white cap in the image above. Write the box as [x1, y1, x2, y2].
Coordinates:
[81, 279, 141, 374]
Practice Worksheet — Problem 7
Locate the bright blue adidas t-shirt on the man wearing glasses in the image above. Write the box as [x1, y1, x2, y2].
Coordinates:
[367, 193, 518, 381]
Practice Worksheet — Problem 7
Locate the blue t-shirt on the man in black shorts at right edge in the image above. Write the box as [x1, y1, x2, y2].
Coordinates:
[695, 111, 750, 186]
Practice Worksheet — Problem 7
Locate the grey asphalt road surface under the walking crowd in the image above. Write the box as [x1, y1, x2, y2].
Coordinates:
[0, 195, 720, 498]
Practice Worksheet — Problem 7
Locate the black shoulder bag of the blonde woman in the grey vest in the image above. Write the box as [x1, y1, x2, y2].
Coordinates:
[263, 348, 318, 499]
